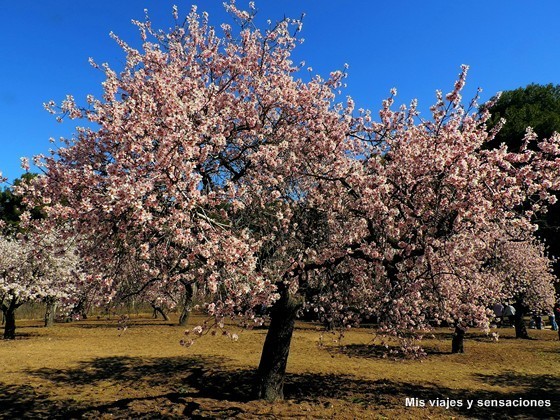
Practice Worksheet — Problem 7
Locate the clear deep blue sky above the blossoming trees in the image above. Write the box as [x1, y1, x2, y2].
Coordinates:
[0, 0, 560, 185]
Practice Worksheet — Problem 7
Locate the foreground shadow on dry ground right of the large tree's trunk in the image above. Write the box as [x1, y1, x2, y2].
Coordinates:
[285, 372, 560, 419]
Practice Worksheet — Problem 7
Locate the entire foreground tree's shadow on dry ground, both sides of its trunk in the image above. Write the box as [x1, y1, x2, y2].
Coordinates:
[7, 357, 560, 419]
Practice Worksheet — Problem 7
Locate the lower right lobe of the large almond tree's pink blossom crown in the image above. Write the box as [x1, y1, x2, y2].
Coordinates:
[304, 71, 560, 351]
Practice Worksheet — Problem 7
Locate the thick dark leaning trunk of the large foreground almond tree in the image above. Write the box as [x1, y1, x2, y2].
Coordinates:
[256, 286, 299, 401]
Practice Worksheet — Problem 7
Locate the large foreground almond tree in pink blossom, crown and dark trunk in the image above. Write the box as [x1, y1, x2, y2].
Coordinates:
[27, 5, 559, 400]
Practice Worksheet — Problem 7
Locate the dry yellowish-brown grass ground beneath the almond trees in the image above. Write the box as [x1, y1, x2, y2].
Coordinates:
[0, 316, 560, 419]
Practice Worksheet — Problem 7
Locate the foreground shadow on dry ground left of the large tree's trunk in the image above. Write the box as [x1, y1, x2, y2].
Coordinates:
[20, 356, 253, 419]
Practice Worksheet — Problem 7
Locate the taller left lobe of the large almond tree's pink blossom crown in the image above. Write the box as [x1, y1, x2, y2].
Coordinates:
[23, 2, 345, 398]
